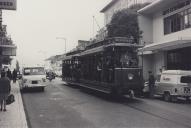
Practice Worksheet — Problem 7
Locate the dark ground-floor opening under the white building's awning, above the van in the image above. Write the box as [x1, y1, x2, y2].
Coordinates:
[167, 47, 191, 70]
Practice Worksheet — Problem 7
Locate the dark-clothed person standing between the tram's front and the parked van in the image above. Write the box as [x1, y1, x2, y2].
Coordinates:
[148, 71, 155, 98]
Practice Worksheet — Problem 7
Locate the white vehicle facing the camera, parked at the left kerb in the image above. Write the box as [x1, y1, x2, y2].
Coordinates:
[20, 67, 46, 91]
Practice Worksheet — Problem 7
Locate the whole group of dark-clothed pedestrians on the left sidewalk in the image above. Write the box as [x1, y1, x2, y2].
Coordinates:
[0, 69, 17, 111]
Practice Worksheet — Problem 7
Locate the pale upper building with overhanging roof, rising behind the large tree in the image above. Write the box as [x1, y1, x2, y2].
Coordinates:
[101, 0, 154, 25]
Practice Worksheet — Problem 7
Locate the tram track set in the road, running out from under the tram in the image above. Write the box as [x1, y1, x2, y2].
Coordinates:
[62, 81, 191, 128]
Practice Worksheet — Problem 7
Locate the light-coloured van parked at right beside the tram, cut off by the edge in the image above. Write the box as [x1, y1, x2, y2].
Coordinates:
[155, 70, 191, 101]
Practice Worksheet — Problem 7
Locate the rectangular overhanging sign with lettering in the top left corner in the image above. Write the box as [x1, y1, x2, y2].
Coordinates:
[0, 0, 17, 10]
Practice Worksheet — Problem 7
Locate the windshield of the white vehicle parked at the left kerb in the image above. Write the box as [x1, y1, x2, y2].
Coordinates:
[24, 67, 45, 75]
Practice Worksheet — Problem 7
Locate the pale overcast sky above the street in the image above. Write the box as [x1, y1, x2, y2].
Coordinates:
[3, 0, 111, 66]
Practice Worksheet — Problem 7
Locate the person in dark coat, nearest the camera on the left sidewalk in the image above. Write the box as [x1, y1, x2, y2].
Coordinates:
[0, 72, 11, 111]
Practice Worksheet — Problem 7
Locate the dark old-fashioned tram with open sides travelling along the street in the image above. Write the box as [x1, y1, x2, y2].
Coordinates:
[62, 37, 143, 96]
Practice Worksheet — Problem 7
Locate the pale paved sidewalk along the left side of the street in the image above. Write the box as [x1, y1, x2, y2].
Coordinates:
[0, 82, 28, 128]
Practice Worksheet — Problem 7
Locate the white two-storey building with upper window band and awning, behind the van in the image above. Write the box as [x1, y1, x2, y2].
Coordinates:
[138, 0, 191, 79]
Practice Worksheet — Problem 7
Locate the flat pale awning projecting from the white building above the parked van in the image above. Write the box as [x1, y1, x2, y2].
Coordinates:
[139, 38, 191, 54]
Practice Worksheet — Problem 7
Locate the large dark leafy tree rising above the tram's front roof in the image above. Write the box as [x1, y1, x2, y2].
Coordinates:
[107, 4, 147, 43]
